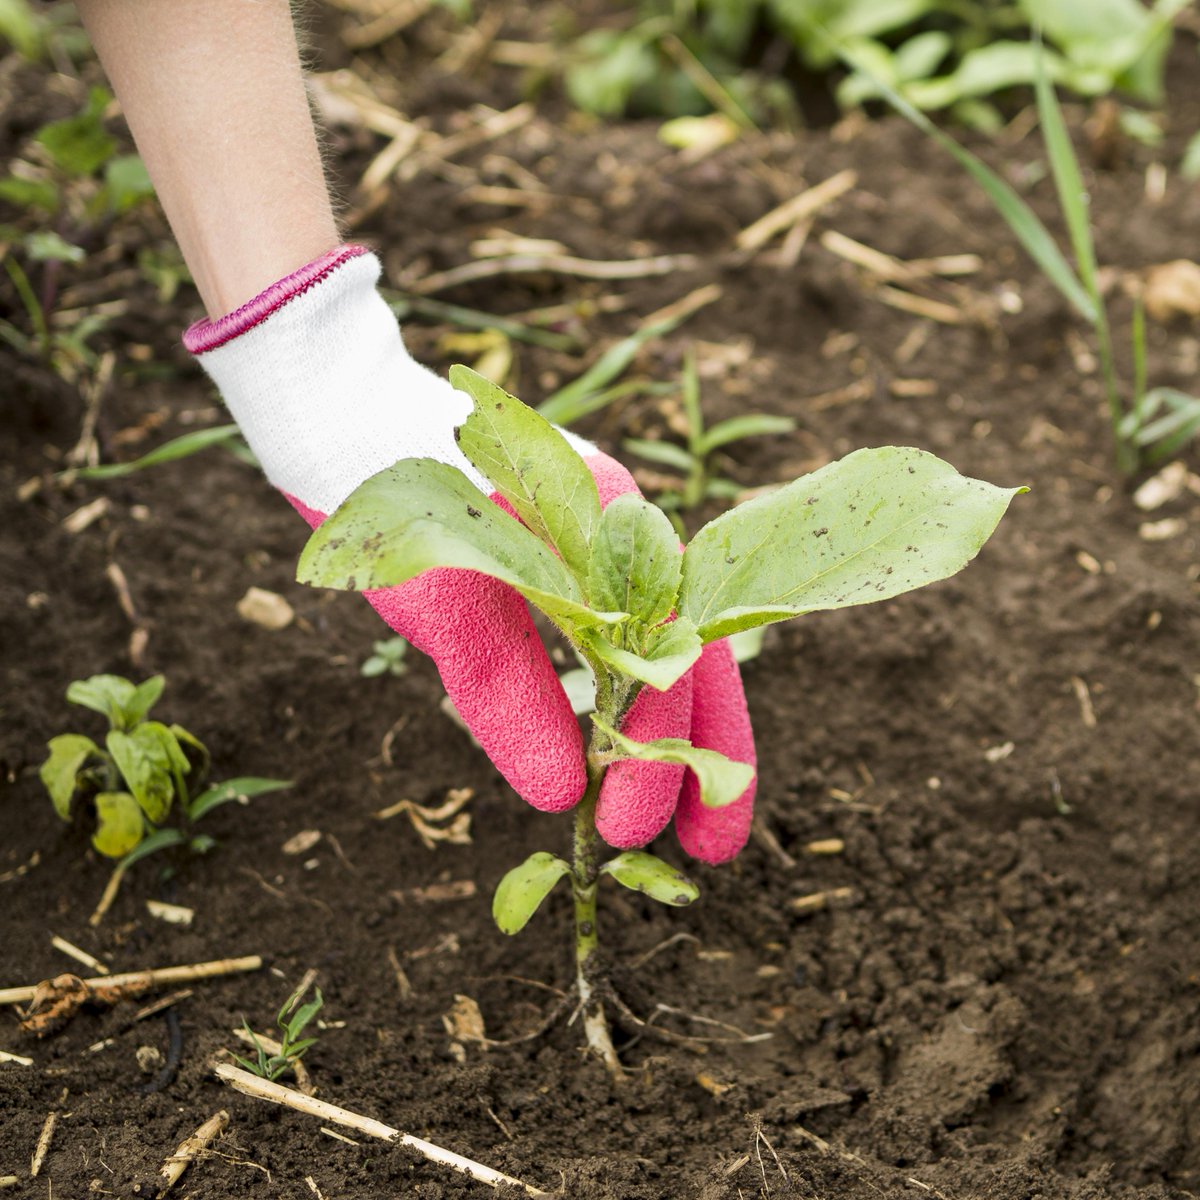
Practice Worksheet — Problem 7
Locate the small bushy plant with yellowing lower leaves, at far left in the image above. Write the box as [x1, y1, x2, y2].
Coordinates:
[38, 674, 292, 871]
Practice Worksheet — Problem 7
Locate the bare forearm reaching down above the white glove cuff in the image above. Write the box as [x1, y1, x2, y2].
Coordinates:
[78, 0, 338, 317]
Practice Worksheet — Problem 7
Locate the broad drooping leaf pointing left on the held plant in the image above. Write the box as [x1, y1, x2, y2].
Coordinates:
[296, 458, 625, 628]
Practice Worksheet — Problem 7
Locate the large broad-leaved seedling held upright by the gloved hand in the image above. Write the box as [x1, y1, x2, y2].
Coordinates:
[298, 366, 1021, 1074]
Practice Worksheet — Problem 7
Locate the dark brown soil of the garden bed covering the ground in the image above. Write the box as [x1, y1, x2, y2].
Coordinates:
[0, 9, 1200, 1200]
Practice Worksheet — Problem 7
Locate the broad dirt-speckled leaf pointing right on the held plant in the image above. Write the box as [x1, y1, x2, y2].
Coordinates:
[679, 446, 1026, 642]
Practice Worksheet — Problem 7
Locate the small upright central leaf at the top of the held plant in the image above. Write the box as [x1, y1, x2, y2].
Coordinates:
[587, 492, 683, 626]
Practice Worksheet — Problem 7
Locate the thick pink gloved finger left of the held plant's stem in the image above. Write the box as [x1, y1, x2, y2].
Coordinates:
[288, 496, 587, 812]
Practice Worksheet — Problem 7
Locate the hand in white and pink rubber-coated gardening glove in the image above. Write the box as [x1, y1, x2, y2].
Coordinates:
[184, 246, 755, 863]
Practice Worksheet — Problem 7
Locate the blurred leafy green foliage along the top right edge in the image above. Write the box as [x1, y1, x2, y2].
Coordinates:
[549, 0, 1189, 128]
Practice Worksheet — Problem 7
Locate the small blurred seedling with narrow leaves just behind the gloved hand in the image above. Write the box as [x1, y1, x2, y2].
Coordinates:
[623, 353, 796, 525]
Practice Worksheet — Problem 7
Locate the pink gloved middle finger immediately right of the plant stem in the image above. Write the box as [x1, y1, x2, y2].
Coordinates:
[595, 671, 692, 850]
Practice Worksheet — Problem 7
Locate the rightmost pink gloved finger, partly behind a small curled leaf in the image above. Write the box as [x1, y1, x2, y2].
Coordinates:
[676, 641, 758, 863]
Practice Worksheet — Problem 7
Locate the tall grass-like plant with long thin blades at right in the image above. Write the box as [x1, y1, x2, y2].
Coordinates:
[841, 30, 1200, 473]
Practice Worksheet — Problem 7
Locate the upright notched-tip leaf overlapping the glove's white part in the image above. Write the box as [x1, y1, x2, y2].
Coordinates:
[450, 366, 600, 580]
